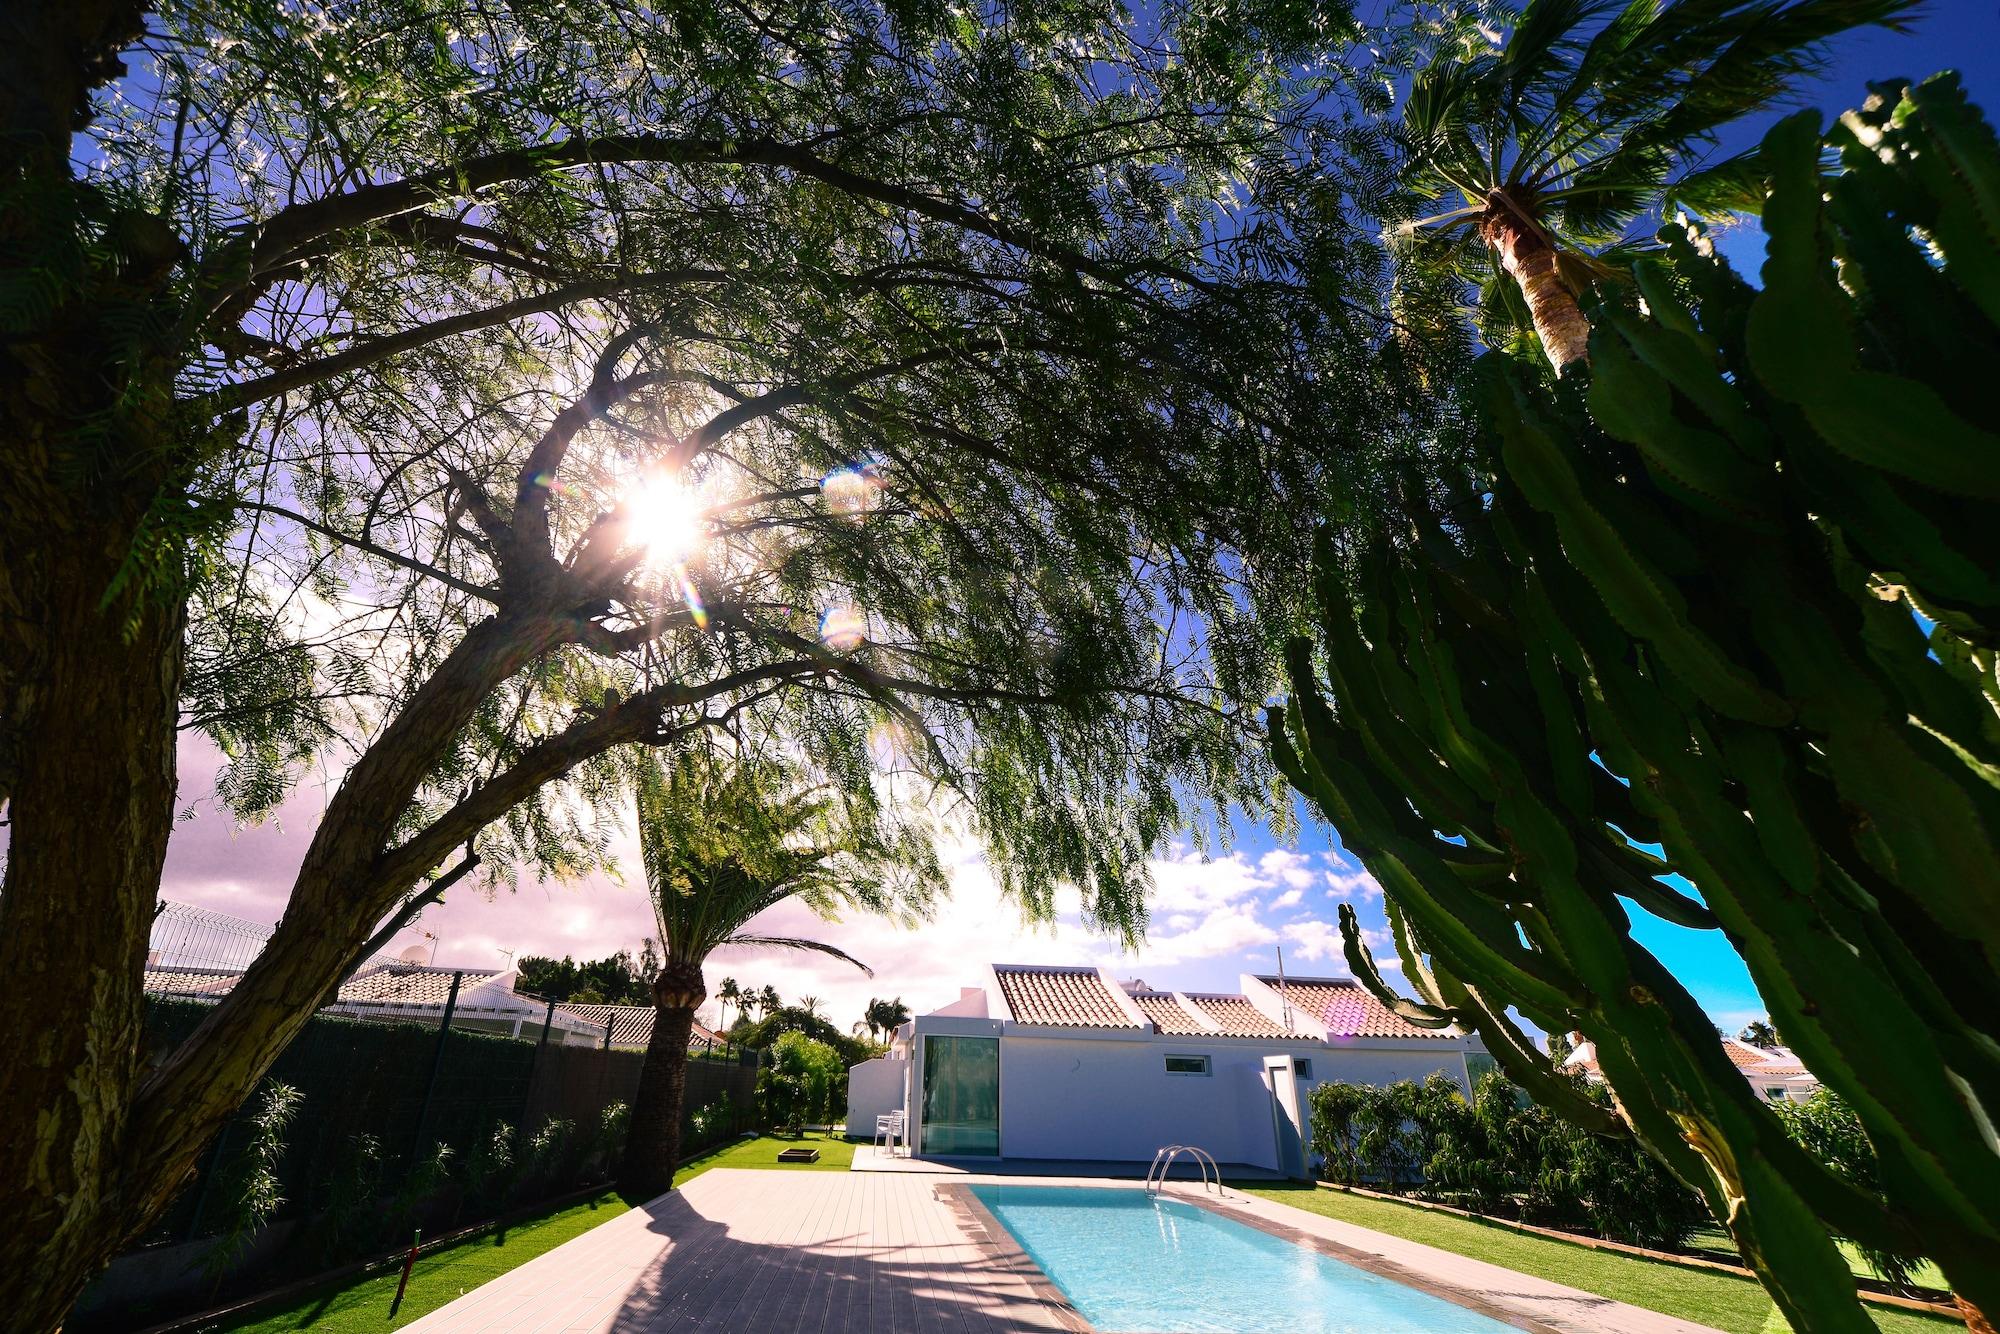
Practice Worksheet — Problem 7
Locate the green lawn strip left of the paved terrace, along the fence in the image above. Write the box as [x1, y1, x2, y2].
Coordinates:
[200, 1136, 854, 1334]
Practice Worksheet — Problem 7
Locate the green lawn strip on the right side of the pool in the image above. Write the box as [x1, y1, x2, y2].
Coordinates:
[1234, 1182, 1964, 1334]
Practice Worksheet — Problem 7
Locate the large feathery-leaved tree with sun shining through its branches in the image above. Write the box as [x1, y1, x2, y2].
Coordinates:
[0, 0, 1344, 1328]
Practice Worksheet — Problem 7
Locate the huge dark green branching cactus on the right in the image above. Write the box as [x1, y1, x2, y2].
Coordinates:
[1270, 76, 2000, 1332]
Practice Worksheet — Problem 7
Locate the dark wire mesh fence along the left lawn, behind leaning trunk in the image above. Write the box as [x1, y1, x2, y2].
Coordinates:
[131, 904, 756, 1246]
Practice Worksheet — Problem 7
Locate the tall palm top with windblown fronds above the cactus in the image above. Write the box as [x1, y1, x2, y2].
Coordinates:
[1400, 0, 1916, 374]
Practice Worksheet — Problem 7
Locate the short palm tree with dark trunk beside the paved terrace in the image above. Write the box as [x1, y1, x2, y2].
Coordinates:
[620, 750, 890, 1196]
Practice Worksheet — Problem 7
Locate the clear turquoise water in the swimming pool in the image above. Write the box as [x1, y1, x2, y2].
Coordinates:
[972, 1186, 1514, 1334]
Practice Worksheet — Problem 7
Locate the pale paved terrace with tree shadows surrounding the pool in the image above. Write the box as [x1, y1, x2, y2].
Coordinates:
[406, 1168, 1712, 1334]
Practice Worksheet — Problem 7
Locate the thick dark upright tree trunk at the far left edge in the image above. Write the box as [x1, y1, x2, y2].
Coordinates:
[0, 408, 186, 1330]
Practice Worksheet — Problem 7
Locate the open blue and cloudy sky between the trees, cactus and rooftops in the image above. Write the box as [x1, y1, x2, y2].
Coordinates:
[164, 0, 2000, 1030]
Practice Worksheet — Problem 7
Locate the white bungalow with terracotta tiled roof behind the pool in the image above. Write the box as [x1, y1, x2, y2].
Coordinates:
[848, 964, 1468, 1176]
